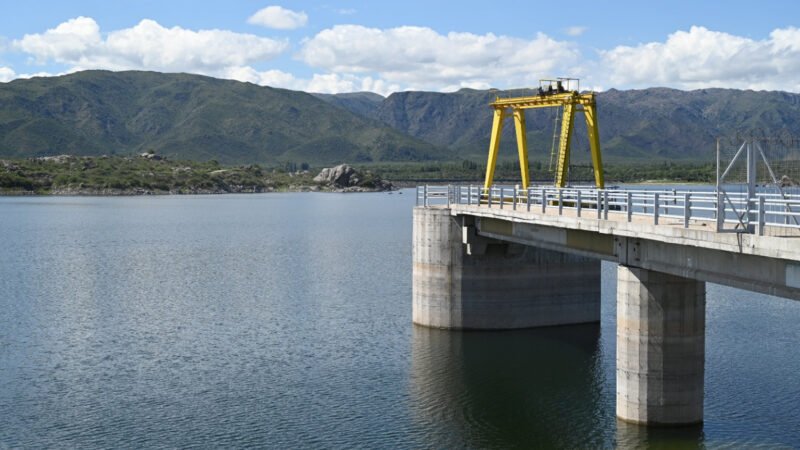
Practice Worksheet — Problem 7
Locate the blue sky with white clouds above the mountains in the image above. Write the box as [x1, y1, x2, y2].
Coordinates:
[0, 0, 800, 95]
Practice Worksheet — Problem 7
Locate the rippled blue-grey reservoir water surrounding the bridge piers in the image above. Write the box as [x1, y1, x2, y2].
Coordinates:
[0, 190, 800, 448]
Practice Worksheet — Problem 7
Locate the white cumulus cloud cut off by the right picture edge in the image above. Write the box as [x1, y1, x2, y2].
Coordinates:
[600, 26, 800, 91]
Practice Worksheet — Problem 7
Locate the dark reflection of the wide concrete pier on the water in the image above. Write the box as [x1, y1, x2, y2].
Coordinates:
[410, 324, 608, 448]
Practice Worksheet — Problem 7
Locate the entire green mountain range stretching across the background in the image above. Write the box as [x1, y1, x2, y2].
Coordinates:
[0, 71, 800, 164]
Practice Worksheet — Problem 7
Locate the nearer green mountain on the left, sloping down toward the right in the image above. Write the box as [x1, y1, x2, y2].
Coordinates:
[0, 71, 442, 164]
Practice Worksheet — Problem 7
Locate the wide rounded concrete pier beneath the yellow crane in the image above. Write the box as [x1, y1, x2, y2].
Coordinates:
[412, 208, 600, 329]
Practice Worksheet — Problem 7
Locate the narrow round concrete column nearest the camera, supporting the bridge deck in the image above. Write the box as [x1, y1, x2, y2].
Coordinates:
[617, 264, 706, 425]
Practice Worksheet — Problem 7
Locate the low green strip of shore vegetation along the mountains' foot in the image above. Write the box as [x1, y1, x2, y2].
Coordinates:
[0, 155, 715, 195]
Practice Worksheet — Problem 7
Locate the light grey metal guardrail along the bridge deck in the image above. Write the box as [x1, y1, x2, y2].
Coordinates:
[417, 185, 800, 235]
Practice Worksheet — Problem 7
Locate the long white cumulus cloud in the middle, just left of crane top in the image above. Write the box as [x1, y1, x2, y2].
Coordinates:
[297, 25, 579, 90]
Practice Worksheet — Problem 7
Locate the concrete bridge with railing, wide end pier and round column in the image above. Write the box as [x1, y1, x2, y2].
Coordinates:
[413, 186, 800, 425]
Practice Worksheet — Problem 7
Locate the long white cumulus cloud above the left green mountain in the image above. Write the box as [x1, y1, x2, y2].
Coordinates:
[12, 17, 288, 75]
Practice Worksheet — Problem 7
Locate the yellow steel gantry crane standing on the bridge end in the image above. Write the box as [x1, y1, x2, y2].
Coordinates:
[484, 78, 604, 189]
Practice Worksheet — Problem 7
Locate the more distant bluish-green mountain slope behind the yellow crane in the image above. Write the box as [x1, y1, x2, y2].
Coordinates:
[376, 88, 800, 161]
